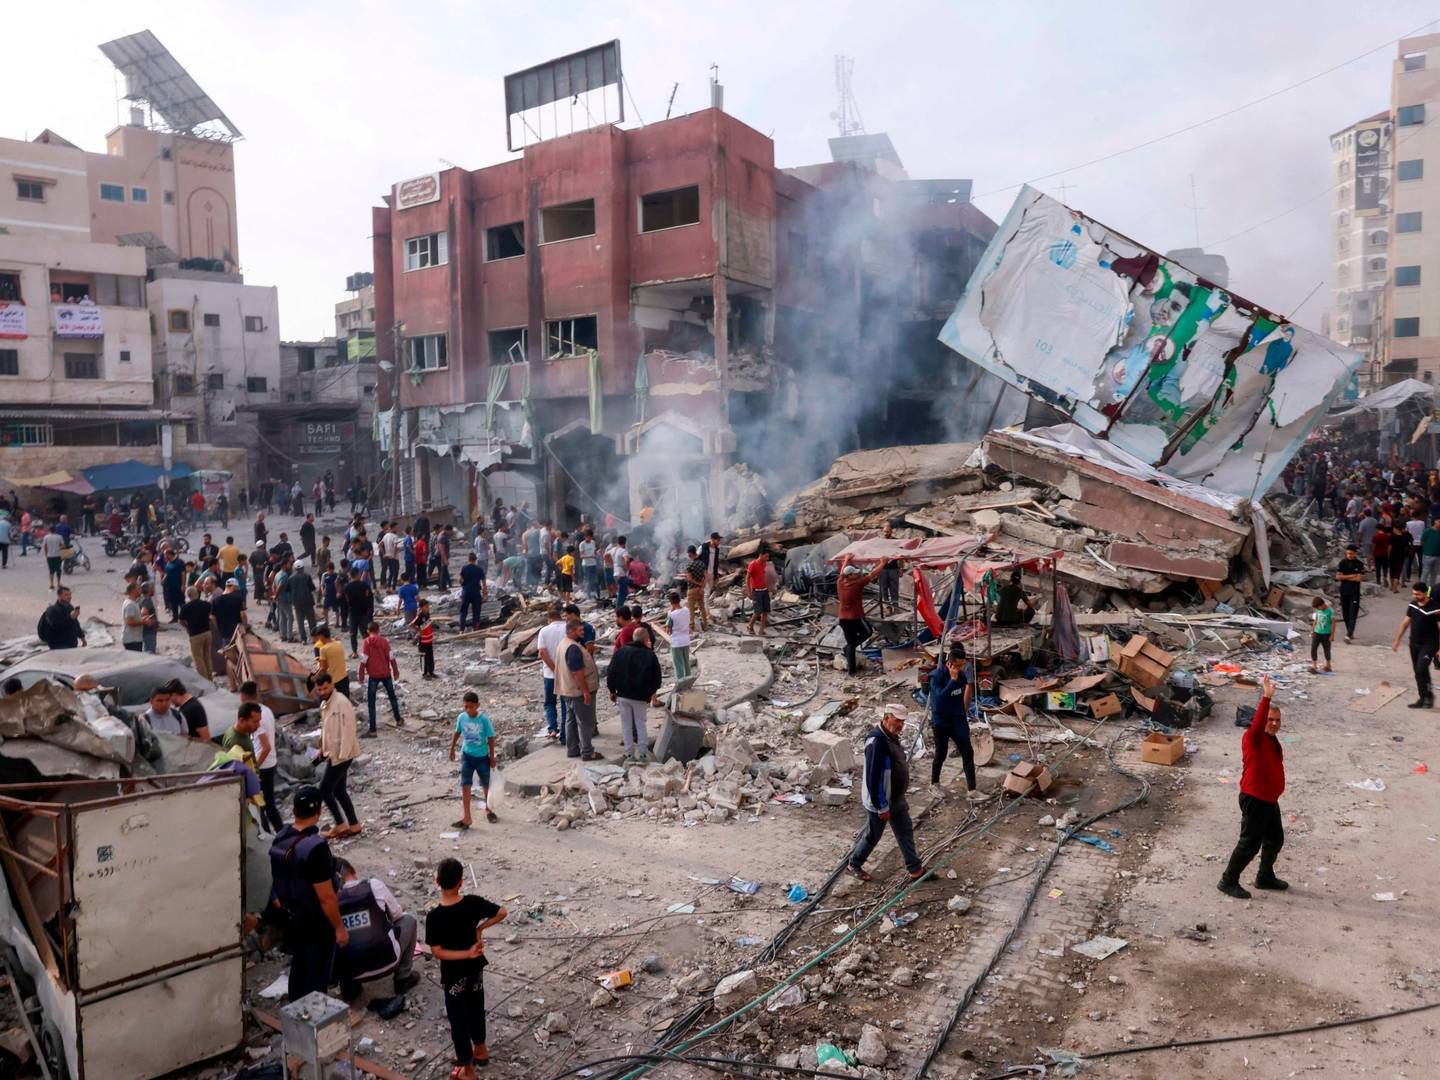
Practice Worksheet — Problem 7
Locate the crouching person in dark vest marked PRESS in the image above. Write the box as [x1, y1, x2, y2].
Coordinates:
[336, 858, 420, 1001]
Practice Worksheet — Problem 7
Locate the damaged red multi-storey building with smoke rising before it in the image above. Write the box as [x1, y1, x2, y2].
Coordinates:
[373, 46, 995, 534]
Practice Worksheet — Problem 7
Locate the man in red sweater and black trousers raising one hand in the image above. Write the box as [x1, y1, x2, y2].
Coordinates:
[1217, 675, 1290, 900]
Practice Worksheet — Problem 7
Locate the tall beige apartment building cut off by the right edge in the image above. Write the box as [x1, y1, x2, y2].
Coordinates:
[1384, 35, 1440, 382]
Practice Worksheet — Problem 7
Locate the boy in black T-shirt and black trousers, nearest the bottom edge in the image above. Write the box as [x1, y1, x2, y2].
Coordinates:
[425, 858, 505, 1080]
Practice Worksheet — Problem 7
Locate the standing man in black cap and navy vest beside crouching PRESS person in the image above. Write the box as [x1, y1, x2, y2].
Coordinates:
[269, 785, 350, 1001]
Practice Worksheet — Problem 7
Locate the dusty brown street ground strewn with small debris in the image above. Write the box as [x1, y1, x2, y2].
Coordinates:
[0, 520, 1440, 1079]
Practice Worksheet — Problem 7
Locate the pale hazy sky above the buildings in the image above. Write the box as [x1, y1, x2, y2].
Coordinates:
[11, 0, 1440, 338]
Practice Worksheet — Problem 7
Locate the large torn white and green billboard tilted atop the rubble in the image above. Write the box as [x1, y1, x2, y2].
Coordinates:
[940, 187, 1362, 497]
